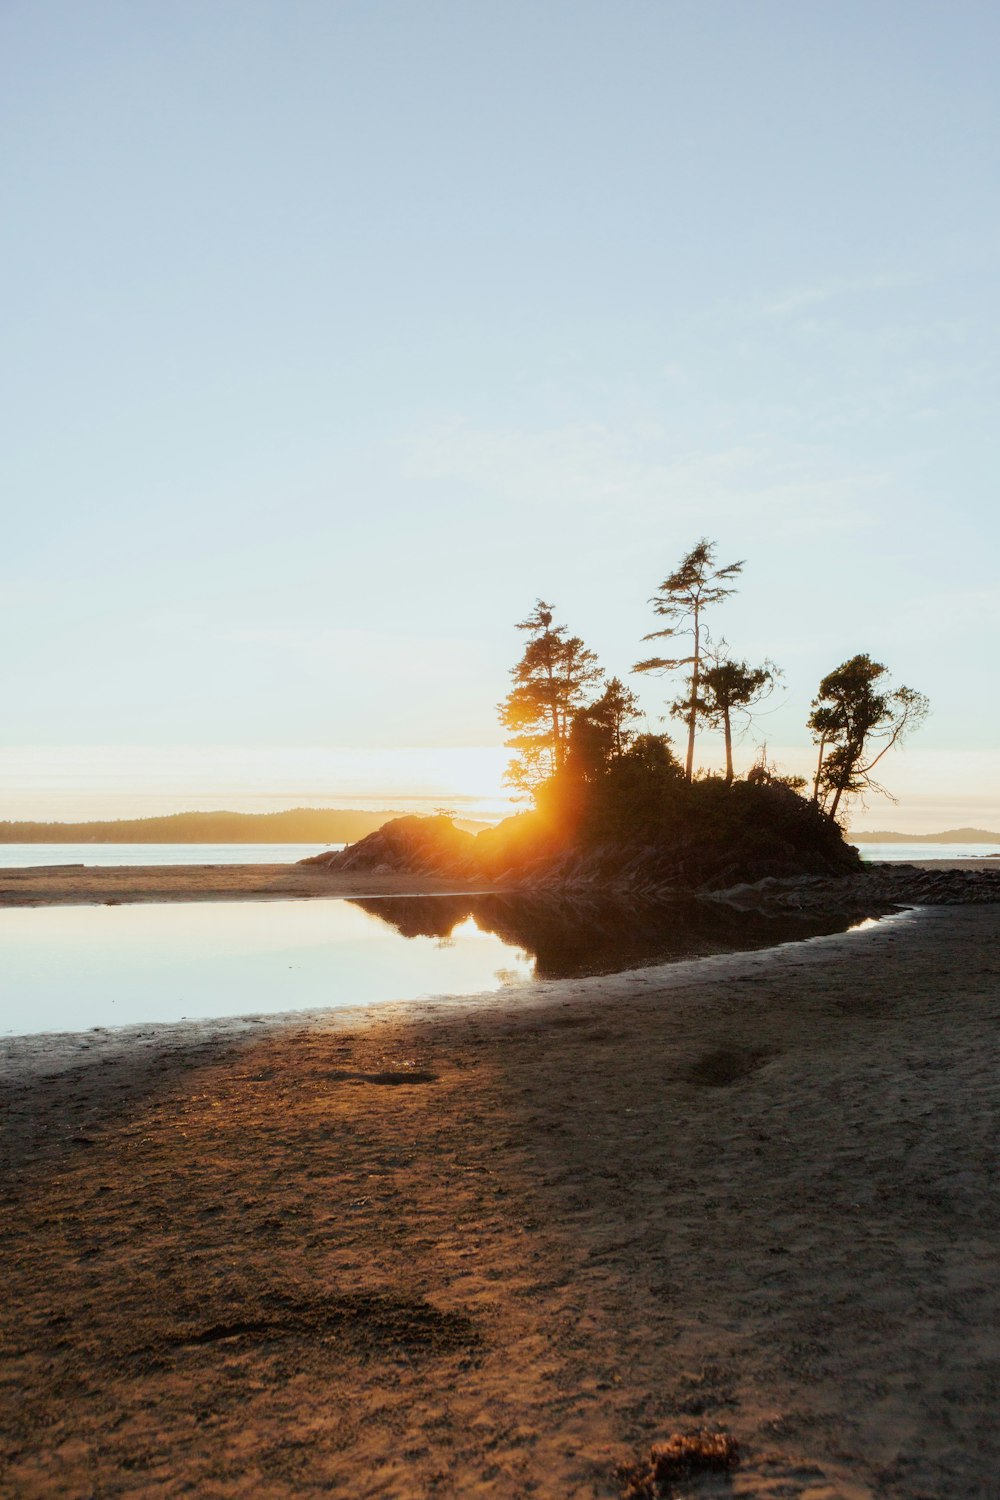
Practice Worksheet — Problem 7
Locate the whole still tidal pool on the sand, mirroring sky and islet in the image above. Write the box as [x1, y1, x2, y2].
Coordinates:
[0, 896, 869, 1035]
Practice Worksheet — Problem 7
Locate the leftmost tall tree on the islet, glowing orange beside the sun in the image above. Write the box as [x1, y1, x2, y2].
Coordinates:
[498, 599, 604, 791]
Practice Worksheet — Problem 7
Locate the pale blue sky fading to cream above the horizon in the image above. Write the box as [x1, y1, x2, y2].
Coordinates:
[0, 0, 1000, 833]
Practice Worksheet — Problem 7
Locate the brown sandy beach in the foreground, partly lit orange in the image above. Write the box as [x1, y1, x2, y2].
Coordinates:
[0, 894, 1000, 1500]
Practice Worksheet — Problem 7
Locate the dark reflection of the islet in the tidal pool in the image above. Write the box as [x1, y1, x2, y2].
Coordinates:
[351, 896, 856, 980]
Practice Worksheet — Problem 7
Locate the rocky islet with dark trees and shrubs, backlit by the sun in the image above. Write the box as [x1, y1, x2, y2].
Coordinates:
[314, 552, 927, 894]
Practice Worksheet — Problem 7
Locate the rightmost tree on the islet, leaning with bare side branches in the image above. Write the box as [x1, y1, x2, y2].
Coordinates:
[808, 653, 930, 818]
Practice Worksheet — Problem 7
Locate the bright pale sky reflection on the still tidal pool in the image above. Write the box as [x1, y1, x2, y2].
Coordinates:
[0, 902, 532, 1035]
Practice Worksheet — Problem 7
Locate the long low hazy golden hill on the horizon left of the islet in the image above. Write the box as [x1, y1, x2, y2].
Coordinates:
[0, 807, 490, 843]
